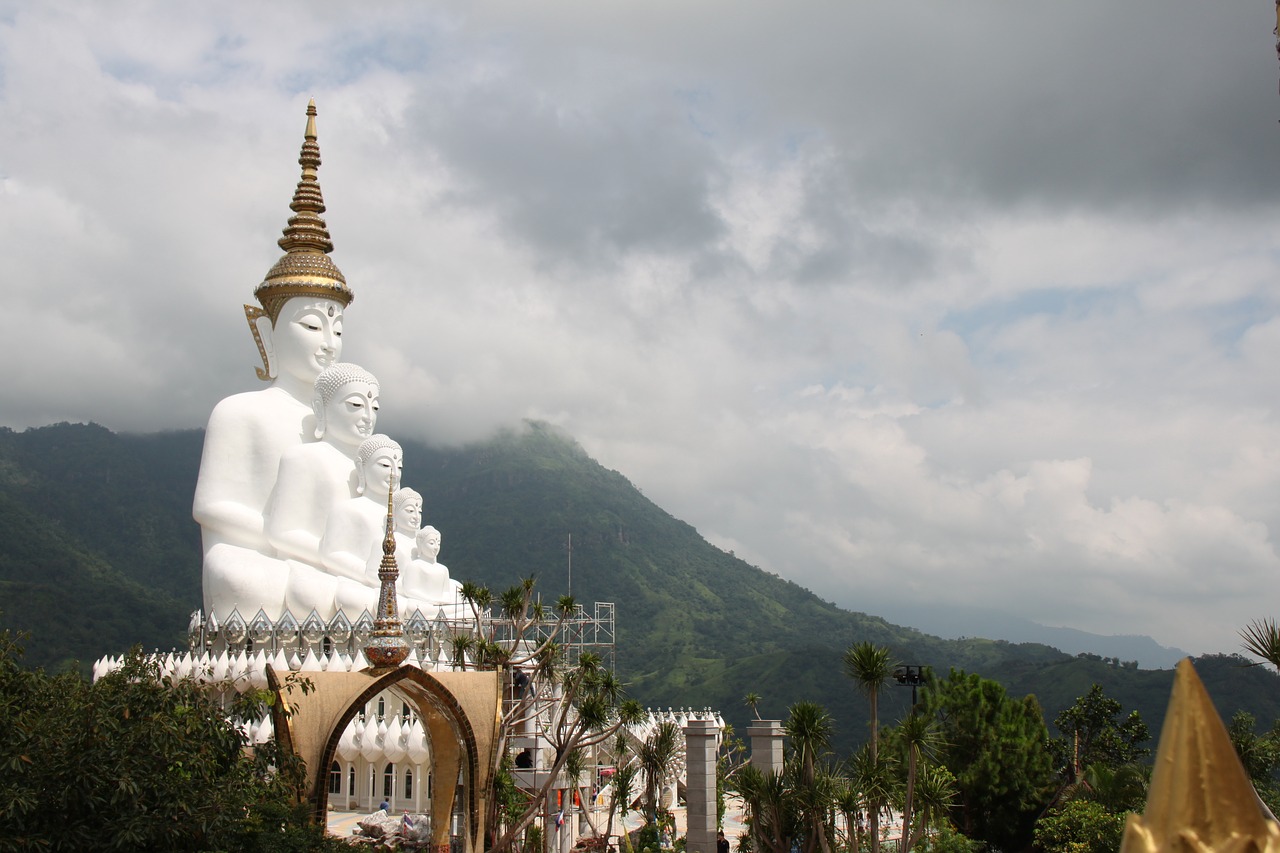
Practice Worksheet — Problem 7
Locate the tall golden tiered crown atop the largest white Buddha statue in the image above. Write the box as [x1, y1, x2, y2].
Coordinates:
[253, 99, 355, 325]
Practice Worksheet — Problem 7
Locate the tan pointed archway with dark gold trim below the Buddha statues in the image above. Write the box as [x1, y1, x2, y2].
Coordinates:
[276, 666, 502, 853]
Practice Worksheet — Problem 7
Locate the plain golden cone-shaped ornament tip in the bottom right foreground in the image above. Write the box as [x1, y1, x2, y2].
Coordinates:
[1120, 658, 1280, 853]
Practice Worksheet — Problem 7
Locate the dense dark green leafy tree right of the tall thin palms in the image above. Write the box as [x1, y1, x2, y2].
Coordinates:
[922, 669, 1053, 849]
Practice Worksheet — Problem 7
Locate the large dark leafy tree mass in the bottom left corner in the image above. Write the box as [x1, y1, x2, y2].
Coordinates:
[0, 631, 340, 850]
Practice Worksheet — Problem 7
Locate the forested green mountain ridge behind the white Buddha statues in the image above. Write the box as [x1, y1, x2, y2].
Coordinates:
[0, 424, 1280, 751]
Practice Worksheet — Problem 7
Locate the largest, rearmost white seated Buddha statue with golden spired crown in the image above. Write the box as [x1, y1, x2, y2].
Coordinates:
[192, 102, 353, 619]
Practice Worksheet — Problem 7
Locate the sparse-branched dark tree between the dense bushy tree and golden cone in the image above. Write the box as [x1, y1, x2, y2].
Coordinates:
[1053, 684, 1151, 784]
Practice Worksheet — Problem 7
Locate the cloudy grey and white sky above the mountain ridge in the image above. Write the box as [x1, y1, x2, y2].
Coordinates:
[0, 0, 1280, 652]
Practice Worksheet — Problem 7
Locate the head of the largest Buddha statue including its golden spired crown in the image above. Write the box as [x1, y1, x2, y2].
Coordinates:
[244, 101, 355, 388]
